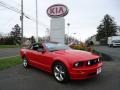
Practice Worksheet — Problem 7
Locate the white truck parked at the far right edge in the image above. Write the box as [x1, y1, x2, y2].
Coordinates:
[107, 36, 120, 47]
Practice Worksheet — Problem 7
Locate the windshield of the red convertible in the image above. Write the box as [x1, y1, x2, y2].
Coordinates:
[45, 43, 70, 51]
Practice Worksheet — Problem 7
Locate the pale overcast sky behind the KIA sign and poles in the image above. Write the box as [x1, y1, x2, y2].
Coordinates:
[0, 0, 120, 41]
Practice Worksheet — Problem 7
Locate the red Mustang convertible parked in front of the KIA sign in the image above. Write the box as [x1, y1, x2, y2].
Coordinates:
[20, 42, 102, 82]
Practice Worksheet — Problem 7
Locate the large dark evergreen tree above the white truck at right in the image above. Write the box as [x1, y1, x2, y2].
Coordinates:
[96, 14, 118, 41]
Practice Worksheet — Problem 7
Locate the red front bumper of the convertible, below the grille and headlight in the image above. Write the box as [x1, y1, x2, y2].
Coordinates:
[70, 62, 103, 79]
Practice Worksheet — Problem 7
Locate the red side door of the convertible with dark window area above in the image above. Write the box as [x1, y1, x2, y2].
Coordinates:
[29, 44, 52, 71]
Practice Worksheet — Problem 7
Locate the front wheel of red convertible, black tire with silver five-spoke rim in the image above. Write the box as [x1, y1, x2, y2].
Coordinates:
[53, 62, 69, 83]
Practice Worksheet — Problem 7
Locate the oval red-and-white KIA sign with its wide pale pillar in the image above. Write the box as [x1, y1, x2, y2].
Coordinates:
[47, 4, 69, 43]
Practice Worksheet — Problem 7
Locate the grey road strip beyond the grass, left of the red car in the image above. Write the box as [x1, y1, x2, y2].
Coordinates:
[0, 48, 20, 58]
